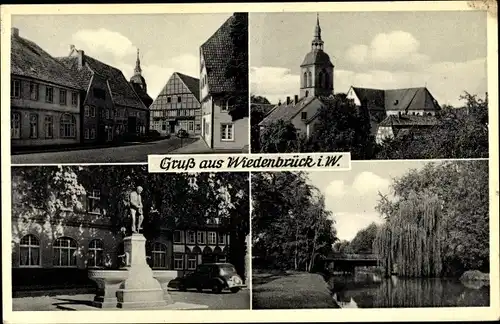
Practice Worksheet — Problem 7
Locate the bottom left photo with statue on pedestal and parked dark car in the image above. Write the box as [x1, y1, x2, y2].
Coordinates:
[11, 165, 251, 311]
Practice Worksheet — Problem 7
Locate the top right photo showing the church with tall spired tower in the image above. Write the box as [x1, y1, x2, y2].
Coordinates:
[249, 11, 488, 160]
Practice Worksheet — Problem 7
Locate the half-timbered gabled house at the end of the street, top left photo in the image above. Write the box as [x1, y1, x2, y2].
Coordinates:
[149, 72, 201, 135]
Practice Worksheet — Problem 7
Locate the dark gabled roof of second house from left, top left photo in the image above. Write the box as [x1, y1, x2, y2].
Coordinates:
[59, 51, 146, 109]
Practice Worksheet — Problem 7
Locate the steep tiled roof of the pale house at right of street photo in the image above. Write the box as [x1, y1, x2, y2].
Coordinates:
[200, 15, 236, 93]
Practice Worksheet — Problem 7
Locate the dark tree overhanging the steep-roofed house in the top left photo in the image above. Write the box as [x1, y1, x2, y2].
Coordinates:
[225, 12, 248, 121]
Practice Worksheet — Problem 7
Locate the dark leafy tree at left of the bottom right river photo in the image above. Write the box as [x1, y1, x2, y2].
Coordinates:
[252, 172, 336, 271]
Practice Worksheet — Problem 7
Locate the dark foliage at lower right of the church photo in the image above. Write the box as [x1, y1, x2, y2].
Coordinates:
[377, 92, 488, 159]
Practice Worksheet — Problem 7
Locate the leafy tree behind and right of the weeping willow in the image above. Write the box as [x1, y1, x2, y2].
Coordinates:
[377, 160, 489, 275]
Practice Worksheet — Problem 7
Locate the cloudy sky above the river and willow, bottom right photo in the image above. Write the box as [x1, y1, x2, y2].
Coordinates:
[308, 161, 427, 240]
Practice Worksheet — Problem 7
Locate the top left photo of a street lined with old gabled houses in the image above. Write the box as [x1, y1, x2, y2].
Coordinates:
[10, 13, 249, 164]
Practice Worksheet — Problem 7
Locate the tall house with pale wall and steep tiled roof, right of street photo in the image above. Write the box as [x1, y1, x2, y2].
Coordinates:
[200, 15, 249, 152]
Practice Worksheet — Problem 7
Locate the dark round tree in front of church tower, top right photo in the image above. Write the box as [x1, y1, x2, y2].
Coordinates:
[311, 93, 375, 159]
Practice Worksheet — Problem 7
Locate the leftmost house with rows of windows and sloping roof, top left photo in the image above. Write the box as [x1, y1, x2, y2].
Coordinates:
[10, 28, 83, 148]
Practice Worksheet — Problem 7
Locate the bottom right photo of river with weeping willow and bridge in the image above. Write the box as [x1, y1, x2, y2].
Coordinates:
[251, 159, 490, 309]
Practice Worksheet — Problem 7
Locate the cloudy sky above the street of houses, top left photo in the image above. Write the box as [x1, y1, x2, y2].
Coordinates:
[12, 13, 231, 98]
